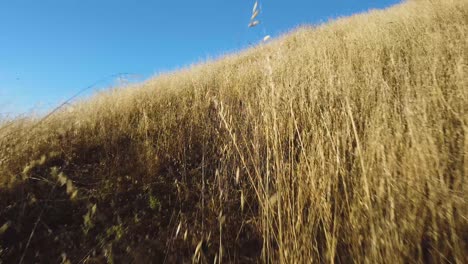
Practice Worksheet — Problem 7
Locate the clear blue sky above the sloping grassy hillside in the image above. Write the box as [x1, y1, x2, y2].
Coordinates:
[0, 0, 400, 115]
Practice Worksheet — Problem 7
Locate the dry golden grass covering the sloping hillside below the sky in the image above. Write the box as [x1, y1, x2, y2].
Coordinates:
[0, 0, 468, 263]
